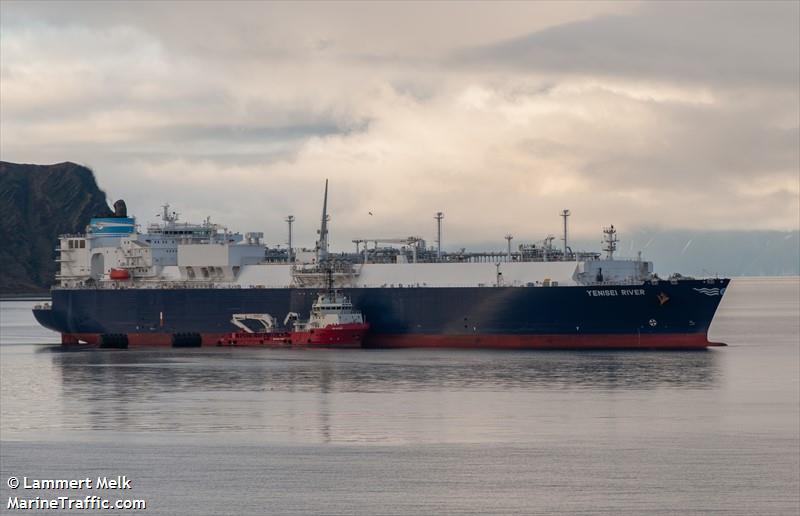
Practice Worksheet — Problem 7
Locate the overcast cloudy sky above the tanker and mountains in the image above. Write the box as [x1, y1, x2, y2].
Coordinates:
[0, 1, 800, 252]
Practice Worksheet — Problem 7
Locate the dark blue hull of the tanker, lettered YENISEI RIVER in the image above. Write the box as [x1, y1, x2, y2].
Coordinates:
[34, 279, 729, 348]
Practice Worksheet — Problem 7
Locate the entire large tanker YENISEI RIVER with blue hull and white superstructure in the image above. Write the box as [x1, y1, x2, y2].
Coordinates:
[34, 182, 729, 349]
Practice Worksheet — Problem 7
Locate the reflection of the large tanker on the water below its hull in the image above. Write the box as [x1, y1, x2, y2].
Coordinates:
[40, 348, 718, 442]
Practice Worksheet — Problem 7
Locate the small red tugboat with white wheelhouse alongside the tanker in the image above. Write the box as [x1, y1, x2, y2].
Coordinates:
[217, 289, 369, 348]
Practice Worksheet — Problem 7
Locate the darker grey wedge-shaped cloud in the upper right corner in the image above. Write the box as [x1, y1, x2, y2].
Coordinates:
[451, 2, 800, 87]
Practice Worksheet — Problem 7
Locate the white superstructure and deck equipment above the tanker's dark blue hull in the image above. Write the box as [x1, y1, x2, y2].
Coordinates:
[56, 186, 654, 288]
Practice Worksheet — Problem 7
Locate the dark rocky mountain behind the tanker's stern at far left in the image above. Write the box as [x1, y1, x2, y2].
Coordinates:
[0, 161, 112, 294]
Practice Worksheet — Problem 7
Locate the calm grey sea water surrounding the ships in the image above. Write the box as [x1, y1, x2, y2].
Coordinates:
[0, 278, 800, 515]
